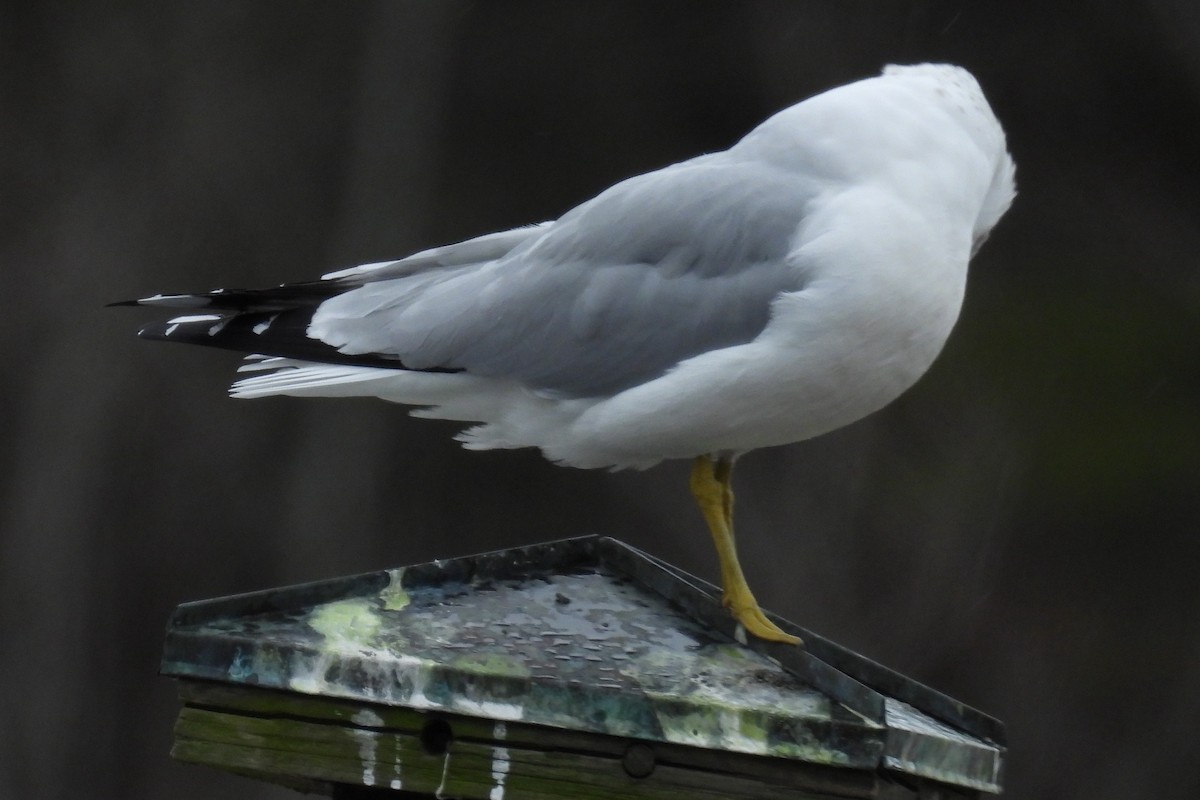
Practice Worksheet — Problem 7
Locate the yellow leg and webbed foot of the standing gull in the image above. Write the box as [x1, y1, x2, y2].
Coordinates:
[691, 456, 800, 644]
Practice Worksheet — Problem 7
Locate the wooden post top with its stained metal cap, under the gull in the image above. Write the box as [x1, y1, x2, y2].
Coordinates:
[162, 537, 1004, 800]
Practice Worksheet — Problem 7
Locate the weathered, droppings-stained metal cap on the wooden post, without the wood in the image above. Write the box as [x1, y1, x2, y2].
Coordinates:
[162, 536, 1003, 792]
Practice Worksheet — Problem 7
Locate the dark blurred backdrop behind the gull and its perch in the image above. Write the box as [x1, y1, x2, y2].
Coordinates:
[0, 0, 1200, 800]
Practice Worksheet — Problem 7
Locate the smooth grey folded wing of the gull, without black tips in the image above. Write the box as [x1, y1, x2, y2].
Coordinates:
[308, 154, 814, 397]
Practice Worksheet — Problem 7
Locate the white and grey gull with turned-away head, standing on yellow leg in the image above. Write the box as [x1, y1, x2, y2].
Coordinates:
[126, 64, 1015, 644]
